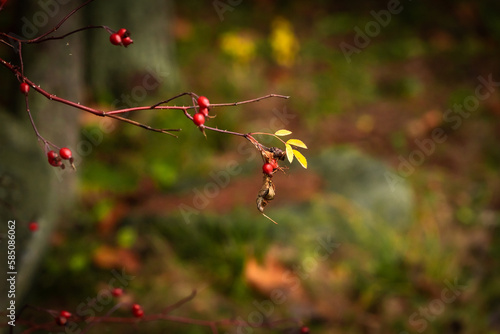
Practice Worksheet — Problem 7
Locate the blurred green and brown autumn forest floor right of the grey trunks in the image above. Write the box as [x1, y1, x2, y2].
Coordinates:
[18, 0, 500, 334]
